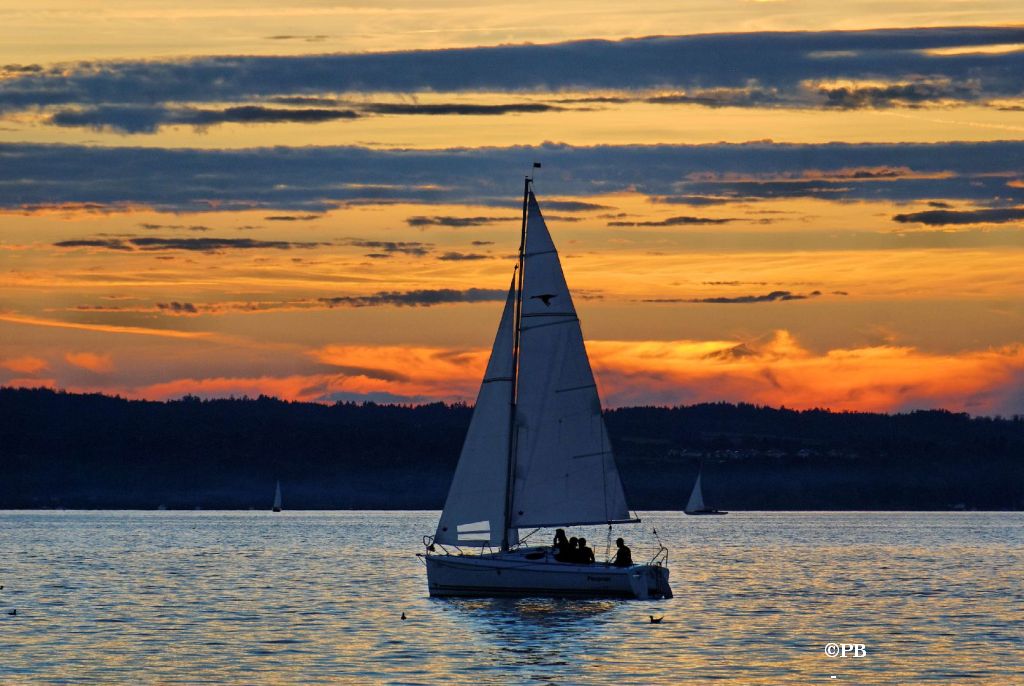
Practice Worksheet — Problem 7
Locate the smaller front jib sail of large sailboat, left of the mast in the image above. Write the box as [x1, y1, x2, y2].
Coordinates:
[434, 285, 518, 547]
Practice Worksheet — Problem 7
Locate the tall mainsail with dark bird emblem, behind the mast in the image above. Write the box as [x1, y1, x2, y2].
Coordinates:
[512, 192, 631, 527]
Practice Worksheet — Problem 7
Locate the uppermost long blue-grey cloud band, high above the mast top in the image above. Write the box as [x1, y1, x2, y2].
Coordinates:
[0, 27, 1024, 116]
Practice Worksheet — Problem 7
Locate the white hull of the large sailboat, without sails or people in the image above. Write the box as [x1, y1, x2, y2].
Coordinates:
[423, 548, 672, 599]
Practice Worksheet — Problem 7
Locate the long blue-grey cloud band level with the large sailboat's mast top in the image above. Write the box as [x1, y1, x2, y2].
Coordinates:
[12, 141, 1024, 211]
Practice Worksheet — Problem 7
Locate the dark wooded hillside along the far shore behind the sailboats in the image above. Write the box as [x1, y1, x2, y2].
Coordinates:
[0, 388, 1024, 510]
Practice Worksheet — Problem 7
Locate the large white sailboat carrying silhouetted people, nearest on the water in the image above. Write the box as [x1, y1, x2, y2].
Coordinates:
[420, 176, 672, 598]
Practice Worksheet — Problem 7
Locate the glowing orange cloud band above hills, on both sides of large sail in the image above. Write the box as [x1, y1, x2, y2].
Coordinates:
[48, 331, 1024, 415]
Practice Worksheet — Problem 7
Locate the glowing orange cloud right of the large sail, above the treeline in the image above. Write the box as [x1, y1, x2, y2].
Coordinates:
[588, 331, 1024, 414]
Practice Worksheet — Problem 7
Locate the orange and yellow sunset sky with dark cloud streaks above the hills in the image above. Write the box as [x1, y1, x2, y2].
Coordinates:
[0, 0, 1024, 415]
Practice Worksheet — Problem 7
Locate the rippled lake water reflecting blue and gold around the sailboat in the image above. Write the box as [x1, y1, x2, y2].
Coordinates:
[0, 512, 1024, 684]
